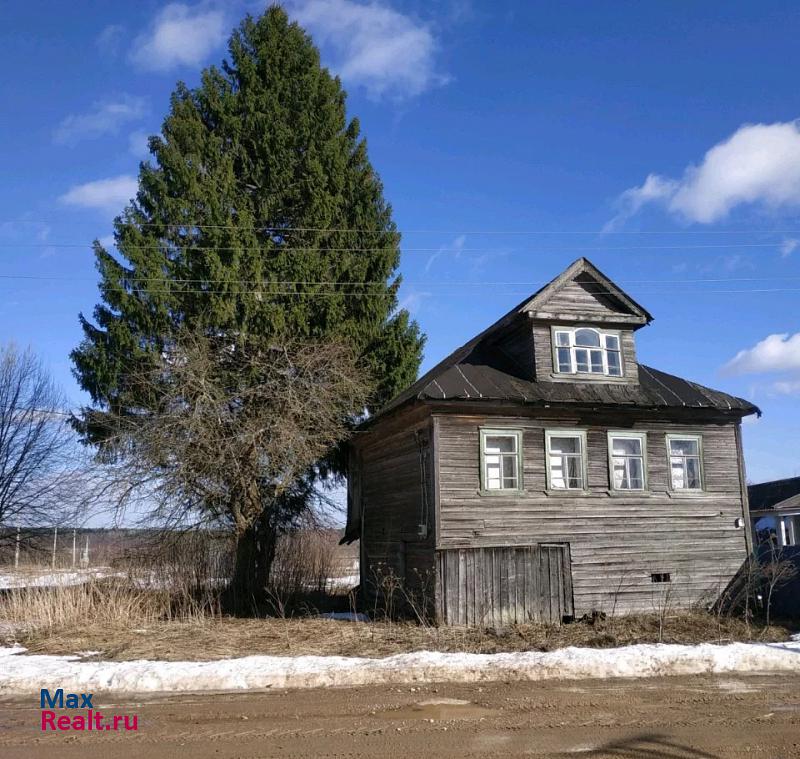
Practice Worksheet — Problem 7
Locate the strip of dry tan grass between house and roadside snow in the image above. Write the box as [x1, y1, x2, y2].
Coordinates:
[4, 612, 790, 661]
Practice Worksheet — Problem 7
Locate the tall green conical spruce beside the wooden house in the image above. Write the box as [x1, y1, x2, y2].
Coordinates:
[72, 2, 423, 604]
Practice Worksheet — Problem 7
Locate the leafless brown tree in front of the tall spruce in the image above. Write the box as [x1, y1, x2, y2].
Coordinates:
[84, 333, 369, 608]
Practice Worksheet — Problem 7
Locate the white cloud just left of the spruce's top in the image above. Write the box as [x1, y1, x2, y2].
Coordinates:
[130, 3, 227, 71]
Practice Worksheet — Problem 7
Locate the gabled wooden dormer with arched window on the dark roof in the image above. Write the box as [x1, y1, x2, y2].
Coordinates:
[520, 258, 653, 384]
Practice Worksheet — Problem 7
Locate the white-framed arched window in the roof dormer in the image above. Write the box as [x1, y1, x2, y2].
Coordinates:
[553, 327, 622, 377]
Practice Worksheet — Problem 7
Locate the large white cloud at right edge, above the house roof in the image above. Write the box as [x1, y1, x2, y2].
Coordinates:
[605, 121, 800, 231]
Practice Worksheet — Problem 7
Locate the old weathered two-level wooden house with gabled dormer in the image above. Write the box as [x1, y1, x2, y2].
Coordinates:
[344, 258, 758, 626]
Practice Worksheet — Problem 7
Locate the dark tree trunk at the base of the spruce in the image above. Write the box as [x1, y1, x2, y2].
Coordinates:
[225, 512, 276, 614]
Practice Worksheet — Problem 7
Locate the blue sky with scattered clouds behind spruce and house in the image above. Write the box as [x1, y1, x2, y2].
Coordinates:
[0, 0, 800, 481]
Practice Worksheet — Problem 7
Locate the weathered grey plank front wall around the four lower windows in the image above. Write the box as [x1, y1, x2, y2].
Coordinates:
[437, 411, 746, 616]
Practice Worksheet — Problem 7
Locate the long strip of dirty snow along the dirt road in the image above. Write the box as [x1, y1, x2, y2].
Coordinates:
[0, 640, 800, 695]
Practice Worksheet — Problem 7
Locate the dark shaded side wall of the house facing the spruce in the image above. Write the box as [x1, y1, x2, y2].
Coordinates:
[352, 408, 435, 603]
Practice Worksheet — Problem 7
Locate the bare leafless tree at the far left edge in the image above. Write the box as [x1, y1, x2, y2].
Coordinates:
[0, 344, 79, 544]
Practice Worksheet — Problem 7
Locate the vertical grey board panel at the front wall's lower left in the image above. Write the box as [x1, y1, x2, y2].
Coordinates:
[436, 544, 573, 627]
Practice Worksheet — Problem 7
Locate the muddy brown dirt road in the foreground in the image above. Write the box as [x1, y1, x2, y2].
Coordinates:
[0, 676, 800, 759]
